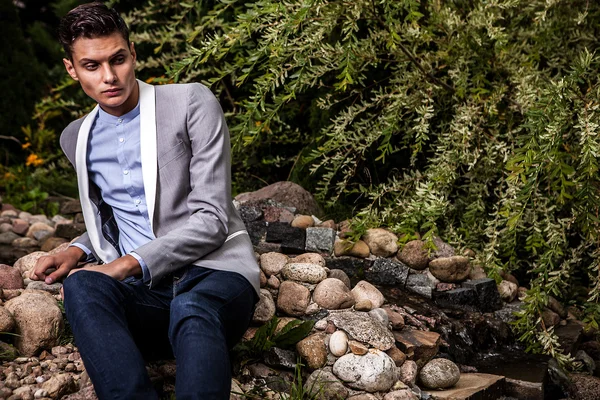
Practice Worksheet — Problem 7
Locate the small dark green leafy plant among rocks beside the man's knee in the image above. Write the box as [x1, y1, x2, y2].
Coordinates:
[233, 316, 315, 361]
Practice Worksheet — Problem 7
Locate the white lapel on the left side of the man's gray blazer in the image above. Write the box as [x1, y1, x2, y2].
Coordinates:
[75, 106, 119, 263]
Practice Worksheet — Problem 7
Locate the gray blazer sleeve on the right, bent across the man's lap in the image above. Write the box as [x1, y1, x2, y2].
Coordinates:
[134, 84, 231, 287]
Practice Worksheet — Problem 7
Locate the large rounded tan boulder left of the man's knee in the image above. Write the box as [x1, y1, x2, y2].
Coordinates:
[4, 290, 63, 354]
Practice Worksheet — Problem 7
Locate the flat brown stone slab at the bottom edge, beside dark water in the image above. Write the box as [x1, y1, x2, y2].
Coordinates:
[424, 373, 505, 400]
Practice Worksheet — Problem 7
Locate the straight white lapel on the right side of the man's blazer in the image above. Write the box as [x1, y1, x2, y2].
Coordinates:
[138, 80, 158, 232]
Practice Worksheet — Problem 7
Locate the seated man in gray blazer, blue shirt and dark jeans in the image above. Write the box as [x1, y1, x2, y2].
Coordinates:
[31, 3, 259, 400]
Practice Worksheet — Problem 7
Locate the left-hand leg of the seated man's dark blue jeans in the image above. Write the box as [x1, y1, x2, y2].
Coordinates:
[64, 271, 172, 400]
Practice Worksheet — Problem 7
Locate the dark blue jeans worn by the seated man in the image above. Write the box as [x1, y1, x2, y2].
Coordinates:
[64, 266, 257, 400]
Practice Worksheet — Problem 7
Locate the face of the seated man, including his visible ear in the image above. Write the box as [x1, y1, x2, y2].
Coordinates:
[63, 32, 139, 116]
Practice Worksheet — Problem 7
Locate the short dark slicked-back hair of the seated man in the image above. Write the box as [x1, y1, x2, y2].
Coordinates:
[58, 1, 129, 60]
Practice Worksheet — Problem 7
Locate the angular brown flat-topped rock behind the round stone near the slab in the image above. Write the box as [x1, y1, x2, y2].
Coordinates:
[393, 329, 441, 368]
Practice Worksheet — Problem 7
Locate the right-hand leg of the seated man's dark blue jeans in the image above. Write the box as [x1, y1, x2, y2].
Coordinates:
[169, 266, 256, 400]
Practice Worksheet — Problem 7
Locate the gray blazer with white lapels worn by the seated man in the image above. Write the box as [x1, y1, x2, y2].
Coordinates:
[60, 81, 260, 293]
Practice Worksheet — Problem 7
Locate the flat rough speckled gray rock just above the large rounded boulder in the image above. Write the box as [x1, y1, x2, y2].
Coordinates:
[327, 311, 394, 351]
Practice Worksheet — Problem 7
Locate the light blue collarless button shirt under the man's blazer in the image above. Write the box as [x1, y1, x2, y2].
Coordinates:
[74, 102, 155, 282]
